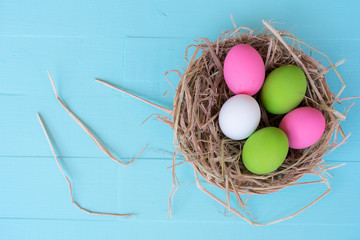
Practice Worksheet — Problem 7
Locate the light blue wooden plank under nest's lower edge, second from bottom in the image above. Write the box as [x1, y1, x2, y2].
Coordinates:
[0, 157, 360, 225]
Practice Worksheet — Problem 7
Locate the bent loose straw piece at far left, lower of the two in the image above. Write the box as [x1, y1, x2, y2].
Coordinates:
[36, 113, 135, 217]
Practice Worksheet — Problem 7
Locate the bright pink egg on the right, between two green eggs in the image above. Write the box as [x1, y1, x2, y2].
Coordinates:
[279, 107, 325, 149]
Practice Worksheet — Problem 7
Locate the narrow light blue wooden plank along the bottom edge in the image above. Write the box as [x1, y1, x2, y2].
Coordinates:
[0, 219, 360, 240]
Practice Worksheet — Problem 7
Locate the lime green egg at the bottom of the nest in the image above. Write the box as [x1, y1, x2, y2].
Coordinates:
[242, 127, 289, 174]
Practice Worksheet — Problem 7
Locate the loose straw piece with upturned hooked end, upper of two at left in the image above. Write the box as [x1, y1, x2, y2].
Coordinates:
[48, 70, 146, 166]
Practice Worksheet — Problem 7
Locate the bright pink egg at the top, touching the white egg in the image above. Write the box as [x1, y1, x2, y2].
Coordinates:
[224, 44, 265, 96]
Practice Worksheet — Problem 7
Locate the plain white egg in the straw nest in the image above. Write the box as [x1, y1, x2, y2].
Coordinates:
[219, 94, 261, 140]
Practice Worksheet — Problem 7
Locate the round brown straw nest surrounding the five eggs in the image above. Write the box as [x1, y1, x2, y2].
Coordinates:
[167, 21, 348, 225]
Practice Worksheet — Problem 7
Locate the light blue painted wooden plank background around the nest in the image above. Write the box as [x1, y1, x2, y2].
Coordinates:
[0, 0, 360, 240]
